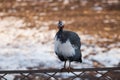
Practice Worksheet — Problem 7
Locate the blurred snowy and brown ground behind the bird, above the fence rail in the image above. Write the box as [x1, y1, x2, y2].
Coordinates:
[0, 0, 120, 70]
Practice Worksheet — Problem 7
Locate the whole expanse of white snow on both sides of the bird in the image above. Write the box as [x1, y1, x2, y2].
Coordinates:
[0, 17, 120, 70]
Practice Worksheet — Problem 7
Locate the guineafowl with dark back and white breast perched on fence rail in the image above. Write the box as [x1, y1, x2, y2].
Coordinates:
[54, 20, 82, 70]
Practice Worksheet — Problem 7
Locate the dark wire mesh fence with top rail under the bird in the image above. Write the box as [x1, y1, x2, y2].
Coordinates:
[0, 67, 120, 80]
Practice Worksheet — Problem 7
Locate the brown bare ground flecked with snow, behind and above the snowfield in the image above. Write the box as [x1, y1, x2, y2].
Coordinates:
[0, 0, 120, 43]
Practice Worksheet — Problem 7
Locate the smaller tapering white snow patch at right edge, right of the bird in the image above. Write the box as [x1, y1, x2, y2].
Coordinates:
[89, 48, 120, 67]
